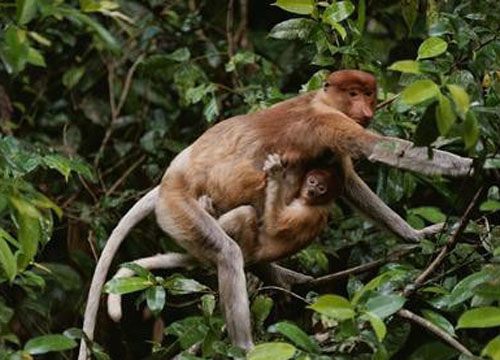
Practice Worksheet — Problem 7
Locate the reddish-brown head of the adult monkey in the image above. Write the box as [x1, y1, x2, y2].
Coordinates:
[323, 70, 377, 127]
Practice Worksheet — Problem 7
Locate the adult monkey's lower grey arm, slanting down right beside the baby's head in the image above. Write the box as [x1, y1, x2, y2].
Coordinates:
[345, 170, 443, 241]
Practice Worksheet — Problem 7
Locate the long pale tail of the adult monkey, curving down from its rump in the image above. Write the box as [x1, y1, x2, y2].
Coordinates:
[78, 186, 160, 360]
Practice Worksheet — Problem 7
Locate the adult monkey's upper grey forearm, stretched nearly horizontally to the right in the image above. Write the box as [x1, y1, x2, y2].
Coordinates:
[366, 137, 472, 176]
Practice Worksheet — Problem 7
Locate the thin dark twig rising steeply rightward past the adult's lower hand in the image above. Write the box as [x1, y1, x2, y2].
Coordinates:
[404, 186, 484, 296]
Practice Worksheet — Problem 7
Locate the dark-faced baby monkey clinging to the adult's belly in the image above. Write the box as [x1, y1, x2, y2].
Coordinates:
[199, 154, 343, 264]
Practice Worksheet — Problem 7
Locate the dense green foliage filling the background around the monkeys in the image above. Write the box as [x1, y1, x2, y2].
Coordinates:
[0, 0, 500, 360]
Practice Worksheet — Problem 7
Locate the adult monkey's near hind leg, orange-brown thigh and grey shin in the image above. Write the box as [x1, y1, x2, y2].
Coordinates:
[156, 187, 253, 349]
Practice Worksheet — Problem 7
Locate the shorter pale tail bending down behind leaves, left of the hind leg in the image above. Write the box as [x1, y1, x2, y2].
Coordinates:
[108, 253, 198, 322]
